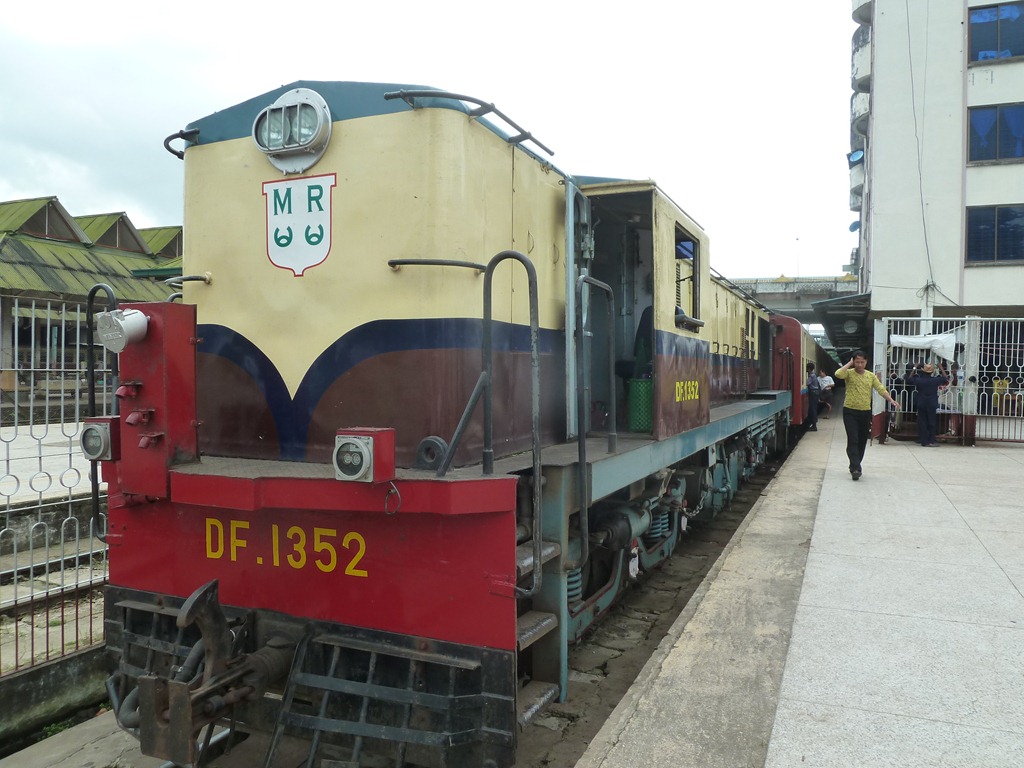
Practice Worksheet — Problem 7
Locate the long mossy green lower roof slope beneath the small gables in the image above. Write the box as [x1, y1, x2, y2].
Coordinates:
[0, 233, 170, 301]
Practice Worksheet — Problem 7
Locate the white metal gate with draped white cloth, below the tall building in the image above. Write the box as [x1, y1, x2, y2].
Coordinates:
[876, 317, 1024, 444]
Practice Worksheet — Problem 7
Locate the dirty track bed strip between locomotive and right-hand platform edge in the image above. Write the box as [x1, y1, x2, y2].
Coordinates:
[515, 459, 782, 768]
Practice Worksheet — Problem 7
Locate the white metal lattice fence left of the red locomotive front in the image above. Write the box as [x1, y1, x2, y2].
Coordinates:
[0, 295, 111, 675]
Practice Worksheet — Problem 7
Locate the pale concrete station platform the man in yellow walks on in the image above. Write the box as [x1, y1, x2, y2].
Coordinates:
[577, 413, 1024, 768]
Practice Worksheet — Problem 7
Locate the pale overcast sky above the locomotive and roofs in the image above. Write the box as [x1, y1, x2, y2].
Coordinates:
[0, 0, 856, 278]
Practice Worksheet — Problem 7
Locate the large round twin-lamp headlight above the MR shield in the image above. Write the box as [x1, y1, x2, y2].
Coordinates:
[252, 88, 331, 173]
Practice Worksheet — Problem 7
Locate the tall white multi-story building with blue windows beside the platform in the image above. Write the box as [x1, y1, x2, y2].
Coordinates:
[821, 0, 1024, 348]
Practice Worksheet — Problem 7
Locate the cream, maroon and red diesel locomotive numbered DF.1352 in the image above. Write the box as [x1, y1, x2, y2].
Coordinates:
[82, 81, 827, 768]
